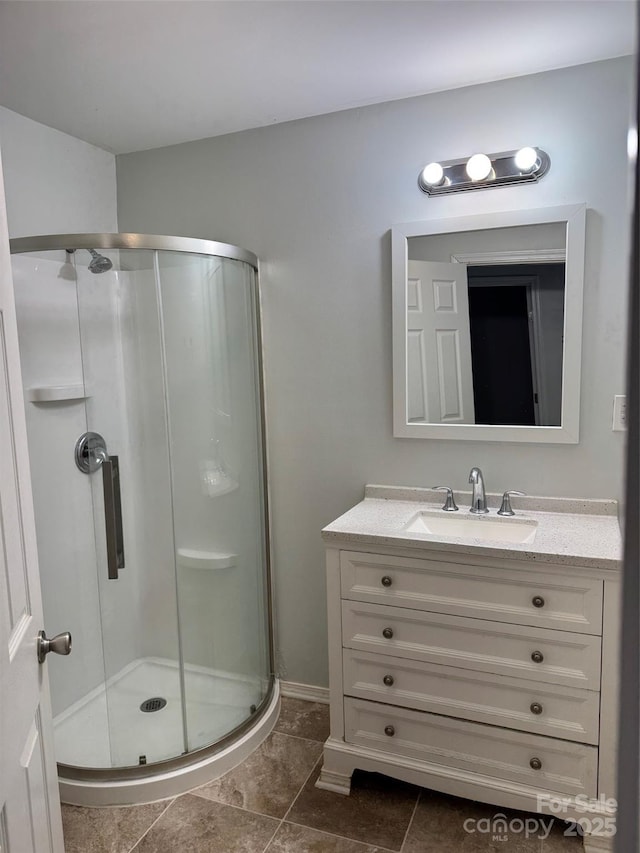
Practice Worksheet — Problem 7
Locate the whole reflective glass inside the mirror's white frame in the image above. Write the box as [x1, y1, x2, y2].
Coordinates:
[407, 251, 565, 426]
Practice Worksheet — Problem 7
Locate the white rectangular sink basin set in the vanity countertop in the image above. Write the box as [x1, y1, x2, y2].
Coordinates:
[404, 512, 538, 544]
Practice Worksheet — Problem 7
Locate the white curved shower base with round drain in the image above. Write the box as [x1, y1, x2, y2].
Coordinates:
[54, 658, 279, 805]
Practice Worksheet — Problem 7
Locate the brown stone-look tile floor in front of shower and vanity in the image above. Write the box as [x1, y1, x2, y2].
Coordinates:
[62, 699, 582, 853]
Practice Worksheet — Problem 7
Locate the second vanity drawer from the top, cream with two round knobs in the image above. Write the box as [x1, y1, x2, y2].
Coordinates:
[342, 601, 600, 690]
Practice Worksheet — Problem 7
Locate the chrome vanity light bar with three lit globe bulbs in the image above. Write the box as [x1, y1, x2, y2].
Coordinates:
[418, 147, 551, 195]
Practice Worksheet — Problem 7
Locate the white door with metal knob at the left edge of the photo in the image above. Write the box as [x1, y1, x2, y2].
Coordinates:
[0, 155, 64, 853]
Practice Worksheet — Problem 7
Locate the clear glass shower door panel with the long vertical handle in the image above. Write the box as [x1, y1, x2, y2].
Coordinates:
[76, 250, 186, 767]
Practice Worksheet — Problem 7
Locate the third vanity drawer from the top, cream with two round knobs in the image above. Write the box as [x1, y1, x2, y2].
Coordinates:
[343, 649, 600, 744]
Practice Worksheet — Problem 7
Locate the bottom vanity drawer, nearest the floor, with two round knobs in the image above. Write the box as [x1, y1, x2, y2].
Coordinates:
[344, 698, 598, 797]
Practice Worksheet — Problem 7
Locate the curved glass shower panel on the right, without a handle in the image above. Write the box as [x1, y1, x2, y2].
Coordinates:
[158, 252, 269, 750]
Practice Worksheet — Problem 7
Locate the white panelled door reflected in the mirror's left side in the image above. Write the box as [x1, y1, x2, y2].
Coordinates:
[407, 261, 475, 424]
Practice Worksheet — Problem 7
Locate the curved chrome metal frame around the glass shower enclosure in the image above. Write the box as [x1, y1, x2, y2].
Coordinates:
[9, 233, 279, 805]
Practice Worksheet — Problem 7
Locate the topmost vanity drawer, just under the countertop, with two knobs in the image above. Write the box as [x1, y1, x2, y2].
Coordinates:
[340, 551, 603, 634]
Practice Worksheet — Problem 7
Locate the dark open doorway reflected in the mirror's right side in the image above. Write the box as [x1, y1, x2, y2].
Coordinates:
[467, 263, 565, 426]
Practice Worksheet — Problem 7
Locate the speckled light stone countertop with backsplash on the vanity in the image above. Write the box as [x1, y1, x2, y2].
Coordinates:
[322, 486, 622, 569]
